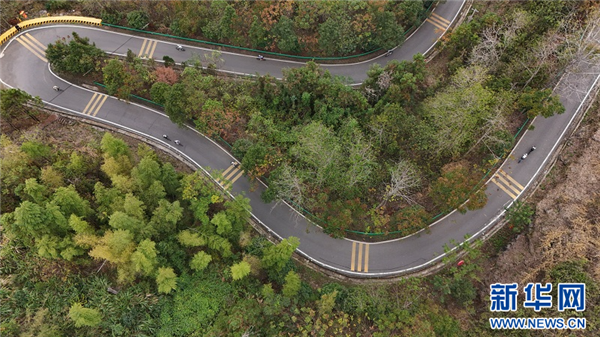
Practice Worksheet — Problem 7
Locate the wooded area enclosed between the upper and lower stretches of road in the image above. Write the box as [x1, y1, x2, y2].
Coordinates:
[37, 2, 589, 237]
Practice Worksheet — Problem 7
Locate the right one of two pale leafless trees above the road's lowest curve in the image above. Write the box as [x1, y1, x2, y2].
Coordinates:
[378, 159, 421, 207]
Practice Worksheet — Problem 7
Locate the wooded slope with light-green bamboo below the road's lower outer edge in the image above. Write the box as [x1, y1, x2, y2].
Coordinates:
[0, 96, 600, 337]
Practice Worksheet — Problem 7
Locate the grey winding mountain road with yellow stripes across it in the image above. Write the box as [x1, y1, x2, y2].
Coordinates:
[0, 1, 600, 278]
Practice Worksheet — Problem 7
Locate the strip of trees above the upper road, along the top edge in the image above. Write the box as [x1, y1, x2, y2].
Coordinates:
[3, 0, 434, 56]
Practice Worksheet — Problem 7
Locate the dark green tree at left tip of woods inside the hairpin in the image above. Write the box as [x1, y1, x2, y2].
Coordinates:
[46, 32, 104, 74]
